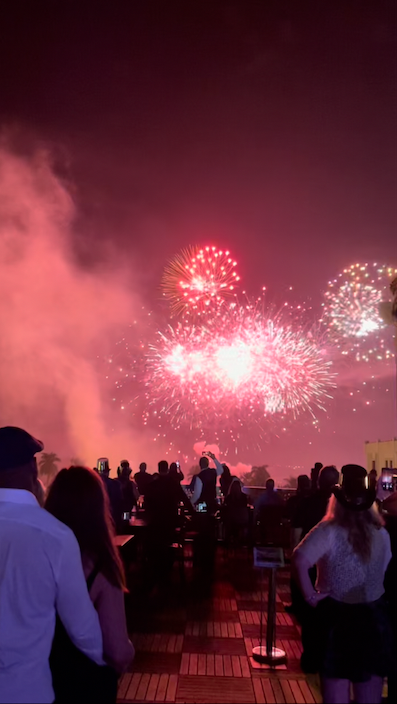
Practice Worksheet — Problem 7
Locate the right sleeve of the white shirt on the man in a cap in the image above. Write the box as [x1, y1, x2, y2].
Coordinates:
[56, 532, 105, 665]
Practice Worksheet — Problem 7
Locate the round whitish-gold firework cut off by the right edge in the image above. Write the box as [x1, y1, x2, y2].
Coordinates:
[321, 263, 397, 362]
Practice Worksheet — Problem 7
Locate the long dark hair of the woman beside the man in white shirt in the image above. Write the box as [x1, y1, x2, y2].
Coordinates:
[45, 467, 125, 590]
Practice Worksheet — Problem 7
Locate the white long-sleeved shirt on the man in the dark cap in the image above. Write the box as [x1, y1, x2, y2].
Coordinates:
[0, 489, 103, 704]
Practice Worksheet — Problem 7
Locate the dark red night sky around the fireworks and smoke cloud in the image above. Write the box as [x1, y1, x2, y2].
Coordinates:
[0, 0, 397, 476]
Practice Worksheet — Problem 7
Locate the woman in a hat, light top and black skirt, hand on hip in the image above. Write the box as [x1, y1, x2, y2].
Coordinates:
[292, 465, 393, 704]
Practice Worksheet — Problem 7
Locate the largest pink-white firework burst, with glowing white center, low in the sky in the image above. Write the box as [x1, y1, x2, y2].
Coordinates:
[147, 304, 333, 428]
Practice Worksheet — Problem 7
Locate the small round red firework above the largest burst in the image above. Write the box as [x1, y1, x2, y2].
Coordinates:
[162, 247, 240, 315]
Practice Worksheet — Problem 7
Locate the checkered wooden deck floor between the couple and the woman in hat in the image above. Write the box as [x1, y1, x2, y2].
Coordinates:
[118, 548, 321, 704]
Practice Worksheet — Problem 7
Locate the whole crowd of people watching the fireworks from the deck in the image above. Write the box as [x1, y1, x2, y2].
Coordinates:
[0, 427, 397, 704]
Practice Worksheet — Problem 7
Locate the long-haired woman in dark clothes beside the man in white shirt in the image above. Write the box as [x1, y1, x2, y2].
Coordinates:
[45, 467, 134, 702]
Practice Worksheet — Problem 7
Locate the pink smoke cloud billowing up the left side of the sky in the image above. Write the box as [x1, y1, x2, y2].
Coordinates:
[0, 144, 152, 466]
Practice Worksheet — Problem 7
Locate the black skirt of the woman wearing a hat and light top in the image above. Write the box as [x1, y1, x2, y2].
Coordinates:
[316, 598, 395, 682]
